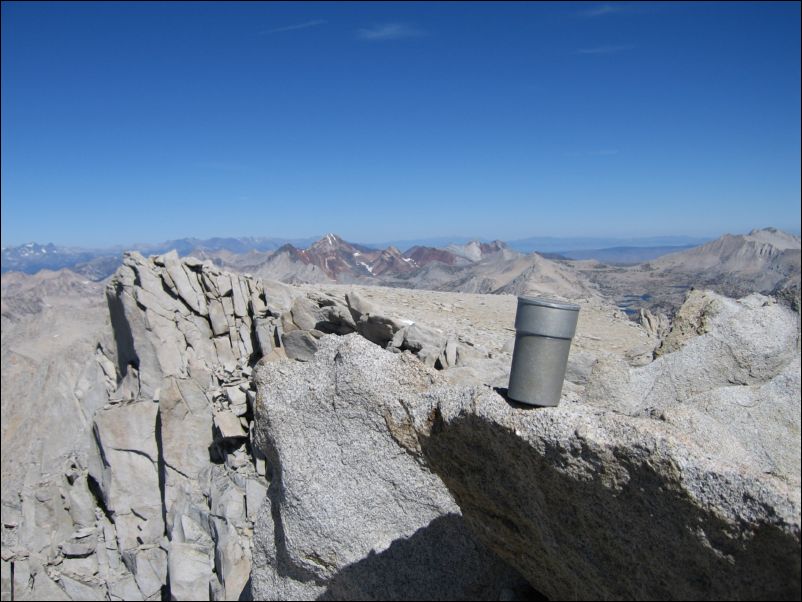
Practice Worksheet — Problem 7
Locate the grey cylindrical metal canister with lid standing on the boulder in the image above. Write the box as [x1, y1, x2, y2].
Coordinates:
[507, 297, 579, 406]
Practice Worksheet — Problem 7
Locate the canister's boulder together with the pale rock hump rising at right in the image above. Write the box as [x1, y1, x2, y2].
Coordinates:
[410, 291, 801, 600]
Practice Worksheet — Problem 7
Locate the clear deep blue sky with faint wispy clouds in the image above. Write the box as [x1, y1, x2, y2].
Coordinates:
[2, 2, 800, 246]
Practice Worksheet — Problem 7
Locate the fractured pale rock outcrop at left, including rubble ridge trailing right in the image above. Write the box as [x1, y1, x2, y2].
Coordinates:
[3, 253, 520, 600]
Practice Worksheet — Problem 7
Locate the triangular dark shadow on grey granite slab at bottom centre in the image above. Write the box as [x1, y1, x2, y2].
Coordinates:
[318, 514, 545, 600]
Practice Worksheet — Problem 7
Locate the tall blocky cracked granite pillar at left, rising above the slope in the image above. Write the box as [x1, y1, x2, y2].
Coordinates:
[89, 253, 276, 599]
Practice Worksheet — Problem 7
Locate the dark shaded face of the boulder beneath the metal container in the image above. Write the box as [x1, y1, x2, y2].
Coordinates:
[420, 414, 800, 600]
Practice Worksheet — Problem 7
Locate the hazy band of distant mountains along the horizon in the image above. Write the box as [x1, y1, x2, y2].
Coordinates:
[3, 228, 800, 314]
